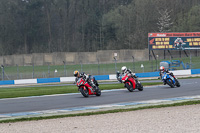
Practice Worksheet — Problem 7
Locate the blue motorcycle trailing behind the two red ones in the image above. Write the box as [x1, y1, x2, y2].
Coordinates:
[162, 72, 181, 88]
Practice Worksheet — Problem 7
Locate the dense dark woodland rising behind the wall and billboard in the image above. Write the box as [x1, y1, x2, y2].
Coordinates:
[0, 0, 200, 55]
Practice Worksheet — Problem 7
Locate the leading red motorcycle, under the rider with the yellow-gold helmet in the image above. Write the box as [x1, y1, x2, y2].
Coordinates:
[76, 78, 101, 97]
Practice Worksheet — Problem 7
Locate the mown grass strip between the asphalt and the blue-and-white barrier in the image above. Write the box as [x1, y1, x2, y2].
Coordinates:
[0, 82, 162, 99]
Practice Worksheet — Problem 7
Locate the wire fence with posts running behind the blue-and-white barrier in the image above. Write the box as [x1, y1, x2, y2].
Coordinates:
[0, 54, 200, 80]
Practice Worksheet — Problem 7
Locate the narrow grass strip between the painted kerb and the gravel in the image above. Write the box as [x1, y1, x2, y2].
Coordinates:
[0, 100, 200, 123]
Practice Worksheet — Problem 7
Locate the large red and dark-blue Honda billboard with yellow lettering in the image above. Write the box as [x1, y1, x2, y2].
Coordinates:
[148, 32, 200, 50]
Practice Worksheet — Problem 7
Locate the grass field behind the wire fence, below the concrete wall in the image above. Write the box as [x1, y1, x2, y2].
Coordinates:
[0, 57, 200, 80]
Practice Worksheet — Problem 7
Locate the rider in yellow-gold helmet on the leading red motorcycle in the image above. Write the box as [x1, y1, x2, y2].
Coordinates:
[74, 70, 98, 91]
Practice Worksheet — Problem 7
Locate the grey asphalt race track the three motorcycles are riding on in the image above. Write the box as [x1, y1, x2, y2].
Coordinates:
[0, 79, 200, 114]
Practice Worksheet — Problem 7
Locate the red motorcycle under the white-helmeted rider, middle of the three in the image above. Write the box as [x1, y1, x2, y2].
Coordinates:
[121, 74, 143, 92]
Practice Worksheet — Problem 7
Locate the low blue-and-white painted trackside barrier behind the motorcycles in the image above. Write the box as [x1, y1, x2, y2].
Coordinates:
[0, 69, 200, 85]
